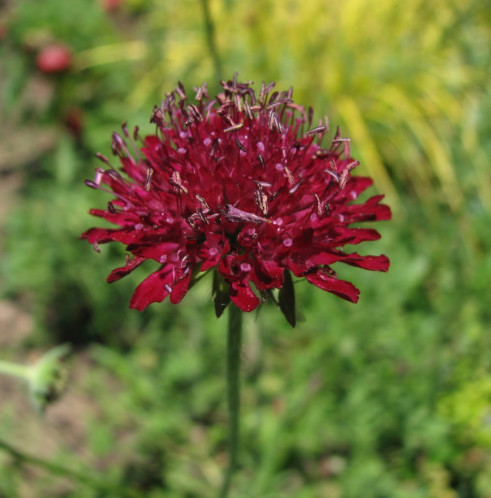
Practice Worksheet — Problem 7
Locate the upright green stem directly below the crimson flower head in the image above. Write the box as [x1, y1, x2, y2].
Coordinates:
[220, 303, 242, 498]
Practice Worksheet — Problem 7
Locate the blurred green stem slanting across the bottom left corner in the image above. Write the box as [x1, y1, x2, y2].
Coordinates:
[0, 439, 141, 498]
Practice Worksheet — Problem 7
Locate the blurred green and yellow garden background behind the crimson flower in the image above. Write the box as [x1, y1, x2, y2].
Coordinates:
[0, 0, 491, 498]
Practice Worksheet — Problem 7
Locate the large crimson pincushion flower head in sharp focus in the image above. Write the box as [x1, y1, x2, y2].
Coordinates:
[82, 76, 391, 324]
